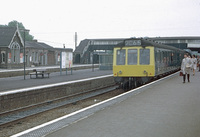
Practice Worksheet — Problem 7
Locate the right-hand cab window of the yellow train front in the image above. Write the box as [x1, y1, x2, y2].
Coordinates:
[140, 49, 150, 65]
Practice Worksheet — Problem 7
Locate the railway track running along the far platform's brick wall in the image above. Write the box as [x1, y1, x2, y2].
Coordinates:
[0, 85, 118, 127]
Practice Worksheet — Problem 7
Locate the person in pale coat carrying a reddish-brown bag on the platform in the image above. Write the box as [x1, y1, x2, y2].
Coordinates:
[181, 54, 192, 83]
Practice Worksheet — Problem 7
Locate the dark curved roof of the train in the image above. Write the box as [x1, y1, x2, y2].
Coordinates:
[115, 38, 183, 51]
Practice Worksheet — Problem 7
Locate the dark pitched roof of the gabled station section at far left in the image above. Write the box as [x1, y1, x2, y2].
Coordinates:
[0, 27, 17, 47]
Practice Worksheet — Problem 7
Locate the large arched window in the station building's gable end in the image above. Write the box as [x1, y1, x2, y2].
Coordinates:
[11, 42, 20, 63]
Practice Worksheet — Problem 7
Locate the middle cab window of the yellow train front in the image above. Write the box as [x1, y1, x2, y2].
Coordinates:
[128, 49, 138, 65]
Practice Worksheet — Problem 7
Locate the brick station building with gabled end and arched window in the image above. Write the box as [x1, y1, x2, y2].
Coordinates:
[0, 27, 73, 69]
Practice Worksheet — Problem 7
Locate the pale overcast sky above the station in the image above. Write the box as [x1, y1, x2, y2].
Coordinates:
[0, 0, 200, 49]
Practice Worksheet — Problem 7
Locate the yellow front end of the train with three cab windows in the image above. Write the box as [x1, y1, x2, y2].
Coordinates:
[113, 46, 155, 78]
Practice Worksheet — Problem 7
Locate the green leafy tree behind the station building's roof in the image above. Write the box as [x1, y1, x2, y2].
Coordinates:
[5, 20, 34, 41]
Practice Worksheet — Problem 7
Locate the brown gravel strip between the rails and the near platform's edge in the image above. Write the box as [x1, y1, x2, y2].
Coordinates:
[0, 89, 124, 137]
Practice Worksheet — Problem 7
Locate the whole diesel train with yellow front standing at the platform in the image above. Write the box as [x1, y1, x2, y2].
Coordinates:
[113, 38, 185, 89]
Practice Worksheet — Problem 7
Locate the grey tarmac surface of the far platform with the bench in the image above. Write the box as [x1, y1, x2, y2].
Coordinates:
[0, 69, 112, 92]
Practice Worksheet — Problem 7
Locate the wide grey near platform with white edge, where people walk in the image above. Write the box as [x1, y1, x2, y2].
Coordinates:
[13, 72, 200, 137]
